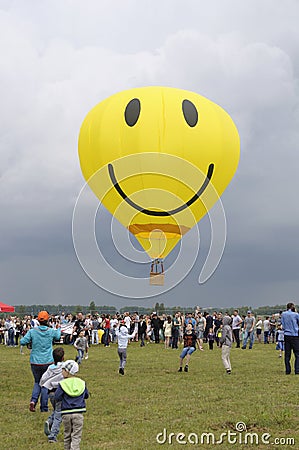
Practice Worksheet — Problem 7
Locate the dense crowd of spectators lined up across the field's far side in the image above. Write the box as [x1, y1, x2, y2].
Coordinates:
[0, 309, 292, 352]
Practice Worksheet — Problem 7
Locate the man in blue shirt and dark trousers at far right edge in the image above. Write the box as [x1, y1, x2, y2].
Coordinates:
[281, 303, 299, 375]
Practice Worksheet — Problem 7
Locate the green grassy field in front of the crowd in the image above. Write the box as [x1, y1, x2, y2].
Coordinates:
[0, 343, 299, 450]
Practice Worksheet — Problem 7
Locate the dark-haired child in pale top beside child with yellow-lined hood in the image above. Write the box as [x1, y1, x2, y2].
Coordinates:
[40, 347, 64, 443]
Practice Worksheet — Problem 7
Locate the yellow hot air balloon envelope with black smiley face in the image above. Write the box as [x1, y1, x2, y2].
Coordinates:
[79, 87, 240, 284]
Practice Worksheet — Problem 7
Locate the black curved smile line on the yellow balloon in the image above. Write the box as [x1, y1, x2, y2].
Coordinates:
[108, 163, 214, 217]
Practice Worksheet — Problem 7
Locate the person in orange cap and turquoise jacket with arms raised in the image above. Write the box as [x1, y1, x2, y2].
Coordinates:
[20, 311, 61, 412]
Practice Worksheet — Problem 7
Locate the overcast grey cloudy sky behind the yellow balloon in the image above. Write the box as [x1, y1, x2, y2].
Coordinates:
[0, 0, 299, 307]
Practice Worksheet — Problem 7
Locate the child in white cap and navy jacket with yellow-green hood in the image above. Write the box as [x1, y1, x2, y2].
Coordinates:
[55, 359, 89, 450]
